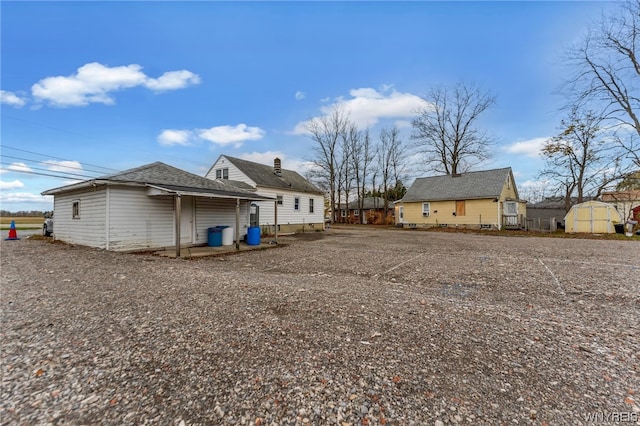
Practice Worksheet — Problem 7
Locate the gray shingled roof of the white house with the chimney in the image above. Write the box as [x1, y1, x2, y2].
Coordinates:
[224, 155, 322, 194]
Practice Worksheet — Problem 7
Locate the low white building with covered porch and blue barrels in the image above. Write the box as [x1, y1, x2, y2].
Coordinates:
[42, 162, 267, 254]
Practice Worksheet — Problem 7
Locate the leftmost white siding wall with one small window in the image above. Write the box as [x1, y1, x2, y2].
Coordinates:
[53, 188, 106, 248]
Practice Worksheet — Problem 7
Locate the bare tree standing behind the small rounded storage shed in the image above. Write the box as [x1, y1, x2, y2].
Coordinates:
[540, 107, 622, 211]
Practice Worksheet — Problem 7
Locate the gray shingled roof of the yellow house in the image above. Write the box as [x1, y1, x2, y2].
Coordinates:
[402, 167, 511, 202]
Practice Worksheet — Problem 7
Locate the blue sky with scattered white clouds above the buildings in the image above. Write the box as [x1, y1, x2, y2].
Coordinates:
[0, 1, 612, 211]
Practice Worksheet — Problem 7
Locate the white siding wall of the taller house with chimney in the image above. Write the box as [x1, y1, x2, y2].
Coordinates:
[255, 188, 324, 226]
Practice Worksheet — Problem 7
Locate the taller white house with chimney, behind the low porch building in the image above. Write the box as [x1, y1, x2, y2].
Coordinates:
[205, 155, 324, 233]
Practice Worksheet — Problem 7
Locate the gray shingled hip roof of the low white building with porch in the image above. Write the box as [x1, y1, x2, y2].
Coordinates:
[43, 161, 266, 199]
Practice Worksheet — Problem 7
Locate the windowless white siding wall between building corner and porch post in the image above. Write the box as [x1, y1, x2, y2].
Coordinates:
[108, 186, 175, 251]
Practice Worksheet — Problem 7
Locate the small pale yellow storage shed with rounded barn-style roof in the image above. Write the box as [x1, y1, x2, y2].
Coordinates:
[564, 201, 622, 234]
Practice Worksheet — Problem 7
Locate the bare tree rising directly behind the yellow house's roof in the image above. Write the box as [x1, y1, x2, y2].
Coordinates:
[412, 83, 496, 174]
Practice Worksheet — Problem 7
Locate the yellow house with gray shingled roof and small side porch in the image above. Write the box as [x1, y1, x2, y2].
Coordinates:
[395, 167, 527, 229]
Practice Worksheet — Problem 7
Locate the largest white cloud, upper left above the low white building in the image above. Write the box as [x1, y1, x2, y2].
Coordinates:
[31, 62, 200, 107]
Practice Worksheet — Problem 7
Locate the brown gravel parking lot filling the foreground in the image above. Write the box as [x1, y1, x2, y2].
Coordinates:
[0, 228, 640, 425]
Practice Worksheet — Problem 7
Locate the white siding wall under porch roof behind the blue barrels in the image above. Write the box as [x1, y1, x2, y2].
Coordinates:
[195, 197, 249, 244]
